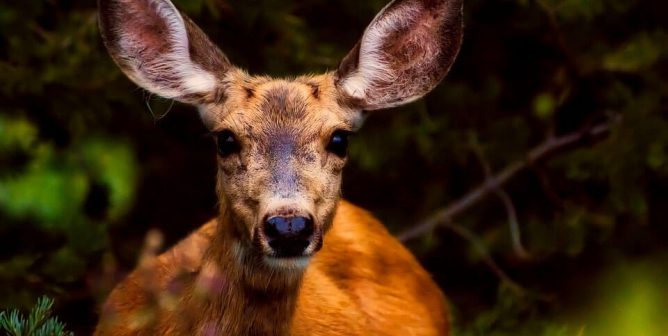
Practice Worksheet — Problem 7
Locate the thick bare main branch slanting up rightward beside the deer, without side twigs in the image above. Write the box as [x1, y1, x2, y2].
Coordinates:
[397, 119, 616, 241]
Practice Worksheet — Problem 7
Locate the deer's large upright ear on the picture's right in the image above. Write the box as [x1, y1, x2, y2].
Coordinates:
[336, 0, 463, 110]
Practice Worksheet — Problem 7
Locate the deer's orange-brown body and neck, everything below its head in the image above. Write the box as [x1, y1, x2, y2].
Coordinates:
[96, 202, 449, 336]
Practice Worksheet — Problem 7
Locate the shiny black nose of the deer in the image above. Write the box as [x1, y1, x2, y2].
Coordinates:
[264, 216, 313, 258]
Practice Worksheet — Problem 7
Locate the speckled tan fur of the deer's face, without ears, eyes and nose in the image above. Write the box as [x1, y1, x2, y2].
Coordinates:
[200, 71, 363, 251]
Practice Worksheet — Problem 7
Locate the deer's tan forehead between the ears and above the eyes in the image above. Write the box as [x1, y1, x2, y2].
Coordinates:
[203, 73, 361, 134]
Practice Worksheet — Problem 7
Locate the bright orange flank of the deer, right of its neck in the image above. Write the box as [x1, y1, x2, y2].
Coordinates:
[293, 201, 449, 335]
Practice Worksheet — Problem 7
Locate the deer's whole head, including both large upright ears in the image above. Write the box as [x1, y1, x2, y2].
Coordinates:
[99, 0, 462, 268]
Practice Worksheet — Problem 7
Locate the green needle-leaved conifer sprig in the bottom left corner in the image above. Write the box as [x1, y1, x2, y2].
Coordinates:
[0, 296, 74, 336]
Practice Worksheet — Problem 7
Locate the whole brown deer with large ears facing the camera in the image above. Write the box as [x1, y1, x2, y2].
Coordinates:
[95, 0, 463, 336]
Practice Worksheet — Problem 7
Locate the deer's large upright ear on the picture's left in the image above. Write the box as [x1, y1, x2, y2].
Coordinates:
[98, 0, 232, 104]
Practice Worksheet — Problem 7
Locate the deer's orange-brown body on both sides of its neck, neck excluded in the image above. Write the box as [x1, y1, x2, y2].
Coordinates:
[98, 201, 449, 336]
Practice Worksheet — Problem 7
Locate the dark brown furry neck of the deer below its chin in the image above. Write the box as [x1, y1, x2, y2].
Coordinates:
[188, 212, 304, 336]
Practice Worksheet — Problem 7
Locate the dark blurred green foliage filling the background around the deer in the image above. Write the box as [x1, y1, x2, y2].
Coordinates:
[0, 0, 668, 336]
